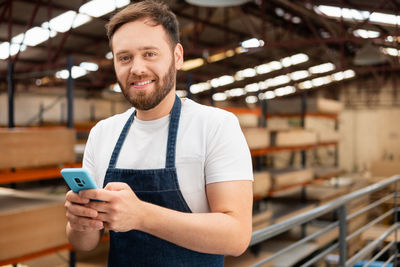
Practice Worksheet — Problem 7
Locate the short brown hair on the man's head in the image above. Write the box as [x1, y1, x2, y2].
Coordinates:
[106, 0, 179, 49]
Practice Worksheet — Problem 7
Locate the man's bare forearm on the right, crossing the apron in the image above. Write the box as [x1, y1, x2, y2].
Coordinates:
[139, 203, 251, 256]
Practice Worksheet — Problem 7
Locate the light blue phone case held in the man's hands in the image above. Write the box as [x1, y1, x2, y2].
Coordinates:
[61, 168, 98, 193]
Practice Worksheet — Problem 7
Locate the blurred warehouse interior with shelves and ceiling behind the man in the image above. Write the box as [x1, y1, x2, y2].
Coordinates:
[0, 0, 400, 267]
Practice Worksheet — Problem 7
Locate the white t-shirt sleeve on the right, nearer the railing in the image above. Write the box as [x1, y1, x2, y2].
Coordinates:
[205, 112, 253, 184]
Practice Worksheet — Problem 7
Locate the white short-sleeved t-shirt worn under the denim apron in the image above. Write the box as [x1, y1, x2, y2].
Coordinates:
[83, 99, 253, 212]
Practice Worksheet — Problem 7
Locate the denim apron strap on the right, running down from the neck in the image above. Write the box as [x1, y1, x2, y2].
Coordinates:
[165, 95, 182, 168]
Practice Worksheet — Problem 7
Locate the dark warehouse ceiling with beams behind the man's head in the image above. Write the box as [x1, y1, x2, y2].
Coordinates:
[0, 0, 400, 103]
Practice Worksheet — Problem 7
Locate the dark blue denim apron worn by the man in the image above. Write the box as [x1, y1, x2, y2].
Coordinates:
[104, 96, 224, 267]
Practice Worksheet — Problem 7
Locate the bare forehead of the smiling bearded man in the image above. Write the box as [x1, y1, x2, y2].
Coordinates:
[112, 19, 170, 53]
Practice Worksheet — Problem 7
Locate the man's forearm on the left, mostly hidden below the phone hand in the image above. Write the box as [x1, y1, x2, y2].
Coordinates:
[66, 222, 103, 251]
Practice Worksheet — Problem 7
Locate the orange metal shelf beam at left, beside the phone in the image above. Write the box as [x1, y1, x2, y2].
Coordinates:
[0, 163, 82, 184]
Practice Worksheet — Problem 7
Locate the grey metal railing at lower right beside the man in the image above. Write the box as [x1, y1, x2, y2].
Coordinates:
[250, 175, 400, 267]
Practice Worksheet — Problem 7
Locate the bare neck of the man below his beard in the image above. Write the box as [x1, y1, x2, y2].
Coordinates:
[136, 90, 175, 121]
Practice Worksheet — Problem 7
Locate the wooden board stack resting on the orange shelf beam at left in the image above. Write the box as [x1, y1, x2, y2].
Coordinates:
[0, 128, 75, 169]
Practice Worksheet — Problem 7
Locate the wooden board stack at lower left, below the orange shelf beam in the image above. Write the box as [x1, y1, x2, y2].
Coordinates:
[0, 189, 68, 261]
